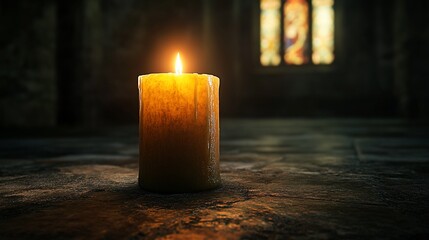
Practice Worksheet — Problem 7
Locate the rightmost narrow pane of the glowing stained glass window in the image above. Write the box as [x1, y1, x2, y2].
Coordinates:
[312, 0, 334, 64]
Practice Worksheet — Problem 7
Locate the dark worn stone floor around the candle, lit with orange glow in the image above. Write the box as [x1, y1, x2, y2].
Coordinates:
[0, 120, 429, 239]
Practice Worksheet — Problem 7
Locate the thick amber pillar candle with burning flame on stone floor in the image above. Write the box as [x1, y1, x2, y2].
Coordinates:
[138, 54, 221, 193]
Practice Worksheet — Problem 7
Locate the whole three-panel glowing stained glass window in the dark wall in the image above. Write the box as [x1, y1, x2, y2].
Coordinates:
[260, 0, 334, 66]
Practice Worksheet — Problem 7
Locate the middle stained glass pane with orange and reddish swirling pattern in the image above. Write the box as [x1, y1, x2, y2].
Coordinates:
[283, 0, 308, 65]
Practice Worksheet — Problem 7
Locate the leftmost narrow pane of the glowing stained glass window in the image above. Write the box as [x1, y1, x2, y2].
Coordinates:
[260, 0, 281, 66]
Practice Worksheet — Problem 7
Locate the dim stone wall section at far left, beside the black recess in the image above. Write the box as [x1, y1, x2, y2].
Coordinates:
[0, 0, 56, 126]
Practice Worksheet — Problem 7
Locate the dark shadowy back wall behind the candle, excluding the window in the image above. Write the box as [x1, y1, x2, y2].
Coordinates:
[0, 0, 429, 127]
